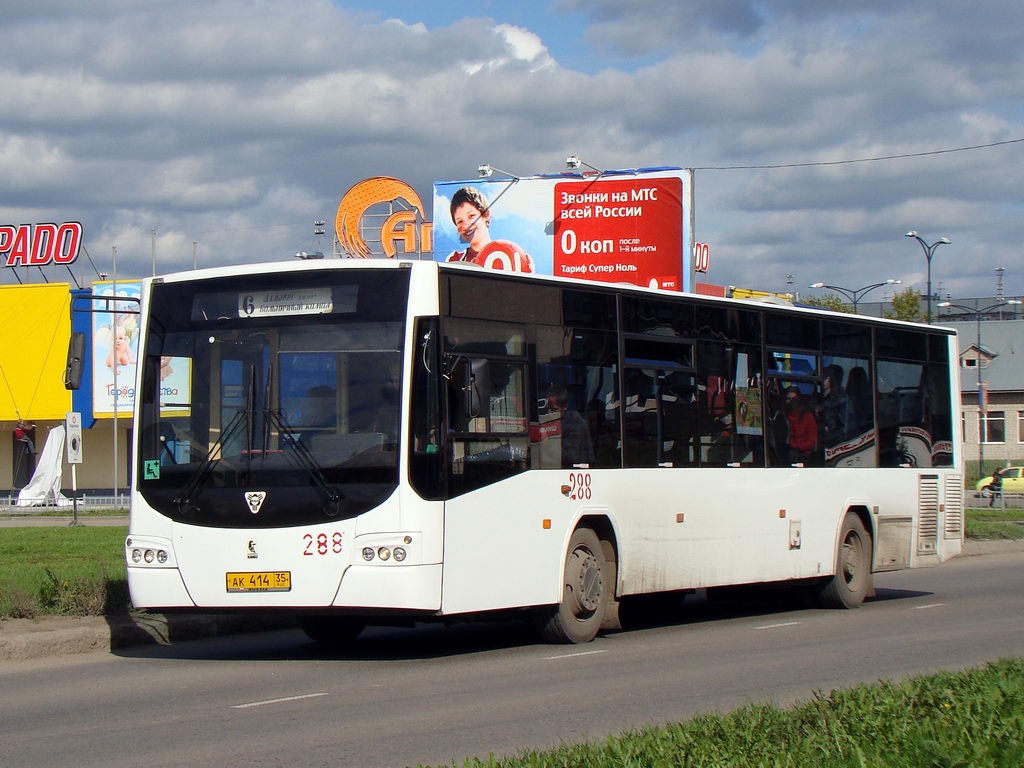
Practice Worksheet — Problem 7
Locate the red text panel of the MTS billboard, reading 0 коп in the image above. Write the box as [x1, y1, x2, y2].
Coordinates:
[554, 177, 684, 291]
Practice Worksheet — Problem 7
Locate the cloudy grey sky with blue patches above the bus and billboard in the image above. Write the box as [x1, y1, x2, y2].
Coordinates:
[0, 0, 1024, 299]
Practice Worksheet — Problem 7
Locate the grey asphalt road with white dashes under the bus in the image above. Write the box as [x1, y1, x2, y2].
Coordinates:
[0, 553, 1024, 768]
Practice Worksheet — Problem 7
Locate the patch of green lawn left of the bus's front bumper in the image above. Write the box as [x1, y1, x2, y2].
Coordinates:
[0, 525, 128, 618]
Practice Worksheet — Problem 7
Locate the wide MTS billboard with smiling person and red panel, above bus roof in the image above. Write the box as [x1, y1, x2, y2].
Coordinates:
[433, 169, 692, 291]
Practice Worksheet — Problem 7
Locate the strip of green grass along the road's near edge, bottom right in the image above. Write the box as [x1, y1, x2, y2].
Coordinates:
[432, 658, 1024, 768]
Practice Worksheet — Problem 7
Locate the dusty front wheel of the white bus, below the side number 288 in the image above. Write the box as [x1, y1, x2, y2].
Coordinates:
[532, 528, 612, 643]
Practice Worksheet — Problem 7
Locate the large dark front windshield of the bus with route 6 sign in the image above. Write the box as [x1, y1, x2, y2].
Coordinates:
[137, 269, 409, 527]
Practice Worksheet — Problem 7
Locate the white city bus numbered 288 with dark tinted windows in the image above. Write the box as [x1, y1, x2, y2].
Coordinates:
[125, 260, 964, 642]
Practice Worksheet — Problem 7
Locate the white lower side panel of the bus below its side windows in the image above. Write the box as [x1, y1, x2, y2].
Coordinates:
[442, 468, 962, 613]
